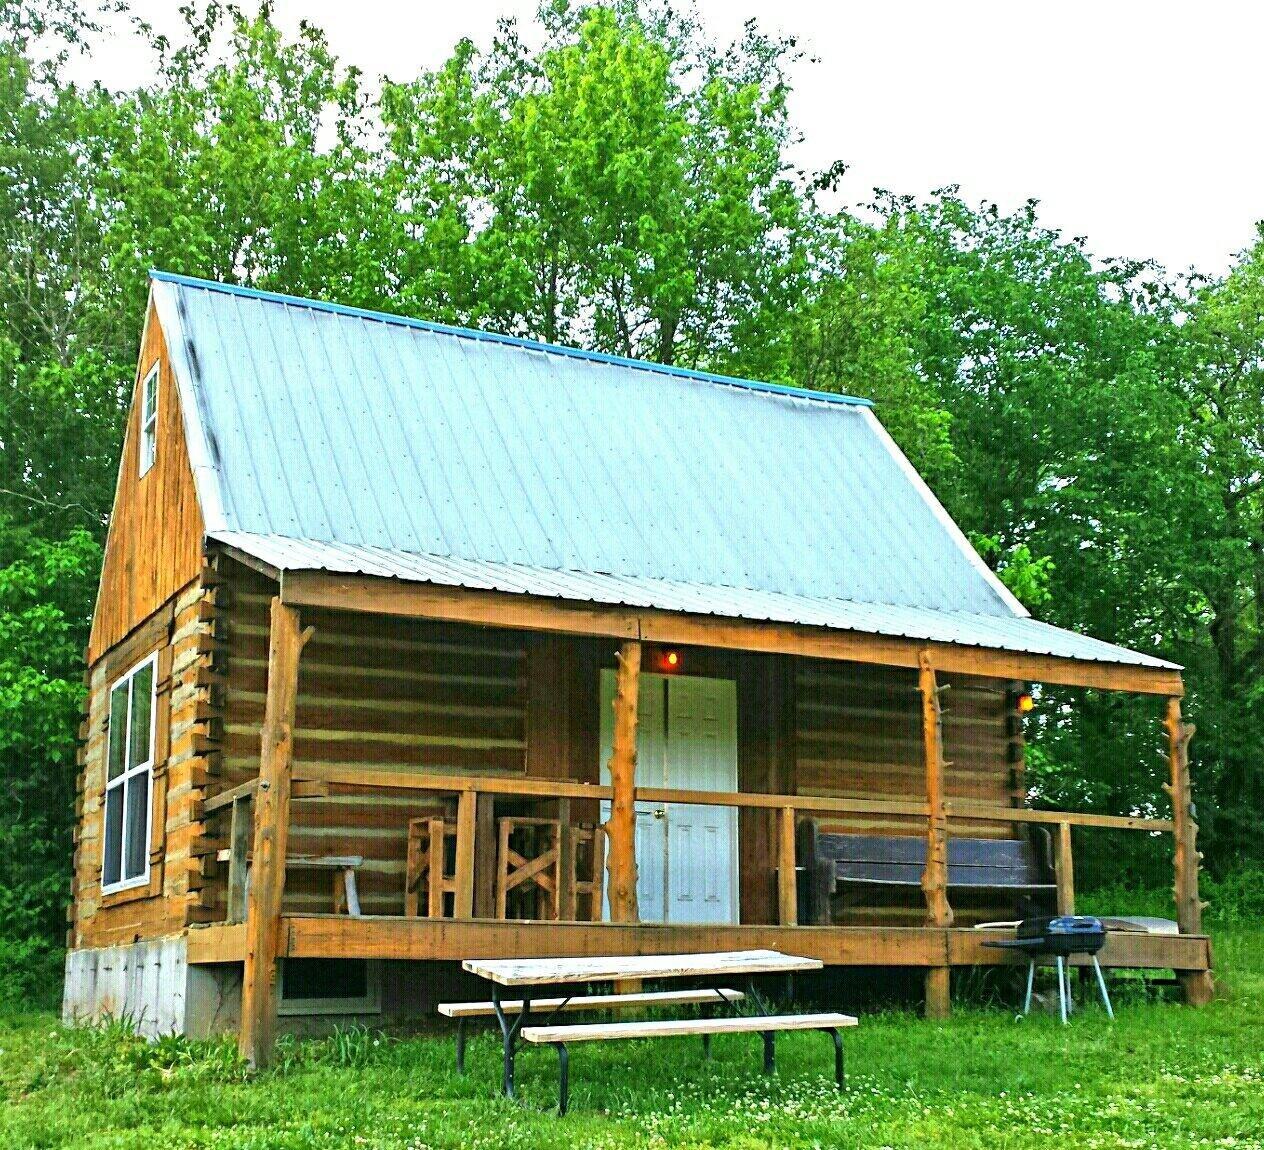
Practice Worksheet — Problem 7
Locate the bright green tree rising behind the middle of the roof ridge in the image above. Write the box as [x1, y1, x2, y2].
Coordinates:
[382, 3, 809, 369]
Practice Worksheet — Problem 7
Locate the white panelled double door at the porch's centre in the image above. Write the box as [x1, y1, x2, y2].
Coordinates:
[602, 671, 738, 923]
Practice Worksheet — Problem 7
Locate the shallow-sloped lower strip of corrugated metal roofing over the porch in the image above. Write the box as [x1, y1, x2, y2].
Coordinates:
[207, 531, 1173, 667]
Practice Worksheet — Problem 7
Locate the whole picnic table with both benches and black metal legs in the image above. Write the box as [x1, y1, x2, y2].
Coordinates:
[439, 950, 856, 1115]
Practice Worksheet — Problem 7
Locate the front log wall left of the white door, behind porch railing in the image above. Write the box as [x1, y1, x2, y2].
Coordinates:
[205, 564, 527, 917]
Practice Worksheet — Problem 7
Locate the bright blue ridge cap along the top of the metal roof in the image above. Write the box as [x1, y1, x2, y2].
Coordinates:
[149, 269, 873, 407]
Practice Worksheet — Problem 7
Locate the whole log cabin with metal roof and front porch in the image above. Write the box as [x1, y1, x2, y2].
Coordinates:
[64, 272, 1211, 1064]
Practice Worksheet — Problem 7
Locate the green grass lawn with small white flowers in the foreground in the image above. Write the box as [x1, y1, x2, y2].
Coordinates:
[0, 928, 1264, 1150]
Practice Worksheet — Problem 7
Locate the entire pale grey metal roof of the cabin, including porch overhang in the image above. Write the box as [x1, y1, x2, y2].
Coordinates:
[152, 273, 1170, 667]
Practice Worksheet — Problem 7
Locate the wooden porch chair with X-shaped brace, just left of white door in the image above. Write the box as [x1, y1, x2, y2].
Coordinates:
[495, 815, 605, 923]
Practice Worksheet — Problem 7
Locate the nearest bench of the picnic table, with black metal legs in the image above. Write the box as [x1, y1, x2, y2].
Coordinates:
[521, 1014, 857, 1115]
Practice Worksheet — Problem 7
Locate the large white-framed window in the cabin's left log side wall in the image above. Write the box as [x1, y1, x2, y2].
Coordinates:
[101, 655, 158, 893]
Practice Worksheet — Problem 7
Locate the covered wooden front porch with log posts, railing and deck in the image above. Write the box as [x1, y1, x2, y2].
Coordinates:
[188, 563, 1211, 1060]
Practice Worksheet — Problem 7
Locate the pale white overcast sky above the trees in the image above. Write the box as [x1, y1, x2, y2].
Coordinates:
[66, 0, 1264, 273]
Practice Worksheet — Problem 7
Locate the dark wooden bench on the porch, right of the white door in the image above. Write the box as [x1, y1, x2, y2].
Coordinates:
[796, 819, 1058, 926]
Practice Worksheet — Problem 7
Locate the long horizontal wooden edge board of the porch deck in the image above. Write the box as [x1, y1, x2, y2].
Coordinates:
[188, 915, 1211, 973]
